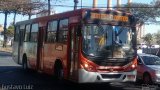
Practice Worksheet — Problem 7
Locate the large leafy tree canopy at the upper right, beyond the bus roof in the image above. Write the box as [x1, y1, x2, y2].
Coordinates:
[124, 1, 160, 25]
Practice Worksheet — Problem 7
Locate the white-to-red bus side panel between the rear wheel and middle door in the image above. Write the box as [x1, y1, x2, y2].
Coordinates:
[23, 42, 37, 69]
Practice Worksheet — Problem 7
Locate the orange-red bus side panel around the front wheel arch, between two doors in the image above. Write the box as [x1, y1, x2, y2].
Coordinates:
[43, 44, 67, 76]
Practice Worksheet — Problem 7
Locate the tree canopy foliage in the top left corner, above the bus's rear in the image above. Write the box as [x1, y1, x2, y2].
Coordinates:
[0, 0, 45, 15]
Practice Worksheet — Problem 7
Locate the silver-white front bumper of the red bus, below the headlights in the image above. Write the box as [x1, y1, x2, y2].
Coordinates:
[79, 69, 137, 83]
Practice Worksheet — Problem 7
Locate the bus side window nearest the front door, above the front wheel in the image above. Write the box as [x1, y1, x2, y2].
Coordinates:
[58, 19, 68, 43]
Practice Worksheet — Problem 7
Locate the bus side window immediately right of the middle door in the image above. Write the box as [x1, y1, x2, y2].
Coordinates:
[47, 21, 58, 43]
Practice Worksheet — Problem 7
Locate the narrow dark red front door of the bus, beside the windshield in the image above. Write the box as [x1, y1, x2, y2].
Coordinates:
[68, 25, 79, 81]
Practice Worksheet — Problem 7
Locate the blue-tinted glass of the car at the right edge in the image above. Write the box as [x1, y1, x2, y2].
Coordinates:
[142, 56, 160, 65]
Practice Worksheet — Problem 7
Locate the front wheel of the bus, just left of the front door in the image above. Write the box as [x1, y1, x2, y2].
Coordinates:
[54, 63, 64, 81]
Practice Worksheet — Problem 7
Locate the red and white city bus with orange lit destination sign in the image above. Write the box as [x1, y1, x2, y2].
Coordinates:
[13, 8, 137, 83]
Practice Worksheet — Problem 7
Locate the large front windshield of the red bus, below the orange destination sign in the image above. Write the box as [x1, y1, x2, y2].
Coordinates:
[82, 24, 134, 58]
